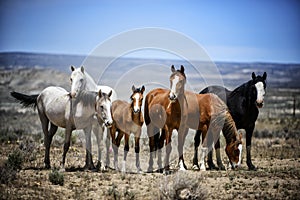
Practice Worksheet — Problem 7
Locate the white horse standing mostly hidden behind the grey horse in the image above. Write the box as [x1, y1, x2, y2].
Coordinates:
[70, 66, 117, 168]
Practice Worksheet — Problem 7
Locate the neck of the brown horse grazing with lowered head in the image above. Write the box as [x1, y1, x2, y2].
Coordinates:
[222, 110, 237, 144]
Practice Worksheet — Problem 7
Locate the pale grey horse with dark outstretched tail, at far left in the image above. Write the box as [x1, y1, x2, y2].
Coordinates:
[11, 86, 113, 170]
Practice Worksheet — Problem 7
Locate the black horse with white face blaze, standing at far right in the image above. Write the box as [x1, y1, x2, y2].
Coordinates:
[193, 72, 267, 170]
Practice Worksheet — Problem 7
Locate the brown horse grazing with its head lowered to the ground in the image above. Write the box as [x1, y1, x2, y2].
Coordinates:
[183, 91, 242, 170]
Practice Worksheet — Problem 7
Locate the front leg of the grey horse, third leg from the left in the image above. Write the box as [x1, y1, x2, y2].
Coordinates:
[83, 126, 95, 170]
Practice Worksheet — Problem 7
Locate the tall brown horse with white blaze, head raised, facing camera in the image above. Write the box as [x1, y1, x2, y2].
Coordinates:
[144, 65, 188, 173]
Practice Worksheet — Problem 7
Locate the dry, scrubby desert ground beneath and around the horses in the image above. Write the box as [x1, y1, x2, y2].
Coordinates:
[0, 68, 300, 199]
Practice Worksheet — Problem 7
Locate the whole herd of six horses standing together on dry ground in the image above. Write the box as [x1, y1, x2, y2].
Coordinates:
[11, 65, 267, 173]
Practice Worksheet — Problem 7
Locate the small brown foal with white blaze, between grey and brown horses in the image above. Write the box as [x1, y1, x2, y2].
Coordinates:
[110, 85, 145, 173]
